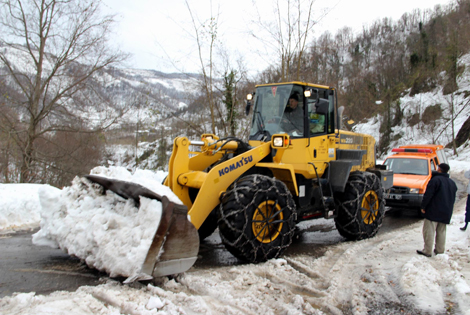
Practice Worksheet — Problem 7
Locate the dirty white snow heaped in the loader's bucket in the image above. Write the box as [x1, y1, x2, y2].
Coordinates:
[33, 167, 178, 277]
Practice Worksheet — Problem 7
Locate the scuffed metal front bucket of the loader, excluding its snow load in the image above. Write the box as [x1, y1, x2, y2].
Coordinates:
[85, 175, 199, 282]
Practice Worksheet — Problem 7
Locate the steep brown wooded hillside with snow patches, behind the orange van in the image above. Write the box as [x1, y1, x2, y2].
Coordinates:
[263, 0, 470, 153]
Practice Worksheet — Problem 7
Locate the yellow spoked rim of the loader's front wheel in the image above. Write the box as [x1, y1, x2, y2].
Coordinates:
[252, 200, 284, 243]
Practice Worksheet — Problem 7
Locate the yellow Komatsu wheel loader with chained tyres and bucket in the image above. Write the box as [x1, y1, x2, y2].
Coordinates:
[88, 82, 393, 278]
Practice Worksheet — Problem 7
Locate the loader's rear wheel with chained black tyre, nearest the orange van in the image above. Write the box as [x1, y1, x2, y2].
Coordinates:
[335, 173, 385, 240]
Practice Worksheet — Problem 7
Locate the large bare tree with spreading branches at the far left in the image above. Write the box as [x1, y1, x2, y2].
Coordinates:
[0, 0, 126, 182]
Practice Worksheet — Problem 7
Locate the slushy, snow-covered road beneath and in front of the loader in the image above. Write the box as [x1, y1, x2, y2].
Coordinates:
[0, 172, 470, 315]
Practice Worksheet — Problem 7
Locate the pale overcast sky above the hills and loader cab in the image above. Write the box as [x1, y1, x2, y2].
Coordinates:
[103, 0, 450, 72]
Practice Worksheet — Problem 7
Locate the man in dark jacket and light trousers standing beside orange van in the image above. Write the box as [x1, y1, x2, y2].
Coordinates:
[417, 163, 457, 257]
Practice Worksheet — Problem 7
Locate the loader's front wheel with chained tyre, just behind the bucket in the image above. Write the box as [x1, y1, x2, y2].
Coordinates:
[218, 175, 297, 263]
